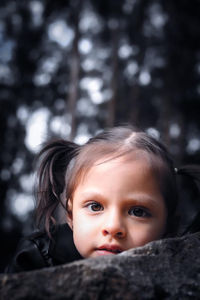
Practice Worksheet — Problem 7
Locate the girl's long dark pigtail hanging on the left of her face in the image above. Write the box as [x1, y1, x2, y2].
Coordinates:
[36, 139, 79, 236]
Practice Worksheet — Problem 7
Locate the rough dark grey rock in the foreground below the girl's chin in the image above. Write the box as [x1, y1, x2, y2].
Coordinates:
[0, 233, 200, 300]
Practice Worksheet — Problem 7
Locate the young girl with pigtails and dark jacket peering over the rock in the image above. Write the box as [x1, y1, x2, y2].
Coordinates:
[7, 127, 200, 272]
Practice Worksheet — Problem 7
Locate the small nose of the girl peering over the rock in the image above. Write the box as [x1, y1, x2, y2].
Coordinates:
[102, 214, 126, 238]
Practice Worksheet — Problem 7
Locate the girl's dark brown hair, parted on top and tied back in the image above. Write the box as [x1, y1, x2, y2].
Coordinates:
[37, 127, 200, 235]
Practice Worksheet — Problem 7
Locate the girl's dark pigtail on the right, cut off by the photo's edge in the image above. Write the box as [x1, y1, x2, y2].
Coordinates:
[175, 165, 200, 235]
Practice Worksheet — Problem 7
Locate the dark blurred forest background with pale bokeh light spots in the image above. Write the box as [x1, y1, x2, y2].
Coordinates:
[0, 0, 200, 271]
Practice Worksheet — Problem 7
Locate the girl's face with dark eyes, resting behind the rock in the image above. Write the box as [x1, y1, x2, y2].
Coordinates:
[68, 157, 167, 258]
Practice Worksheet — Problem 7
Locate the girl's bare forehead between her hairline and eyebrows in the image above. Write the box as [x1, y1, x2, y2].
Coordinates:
[74, 151, 162, 203]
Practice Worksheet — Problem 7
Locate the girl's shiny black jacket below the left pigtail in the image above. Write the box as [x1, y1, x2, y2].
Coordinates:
[5, 224, 82, 273]
